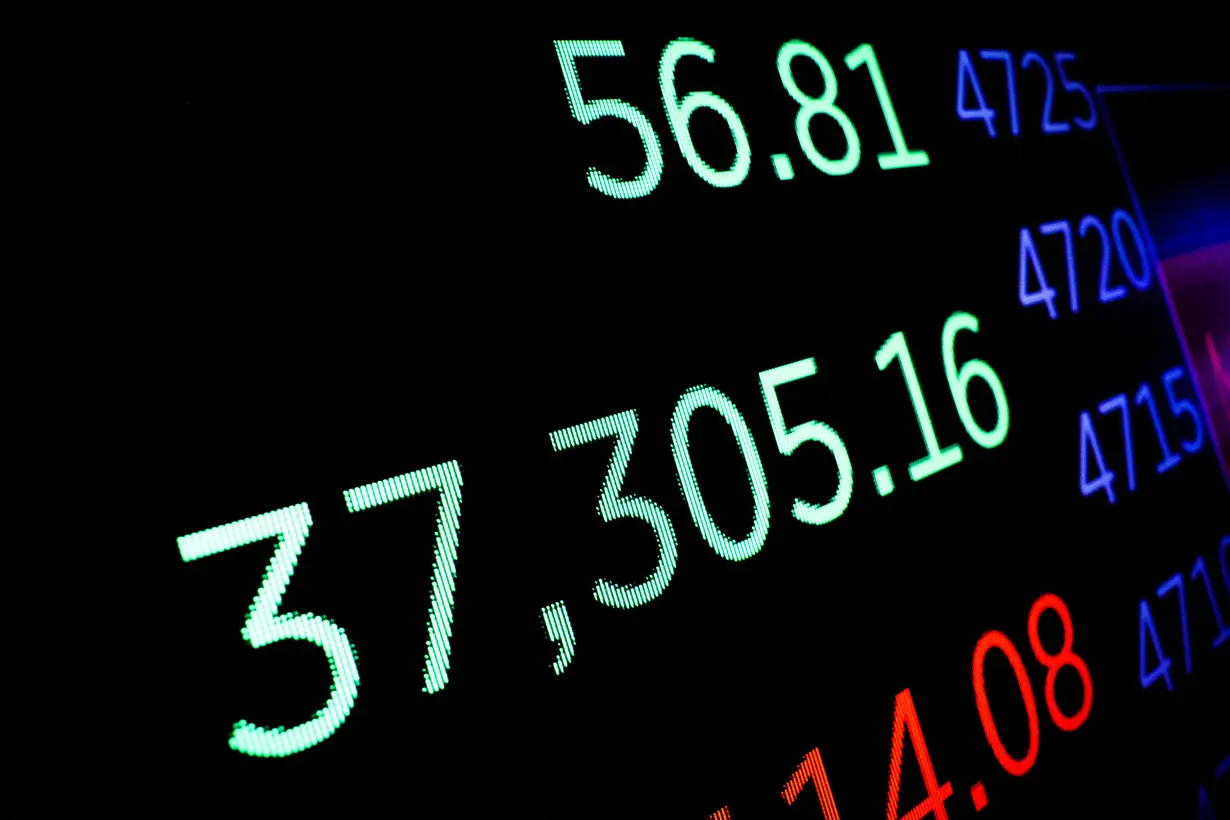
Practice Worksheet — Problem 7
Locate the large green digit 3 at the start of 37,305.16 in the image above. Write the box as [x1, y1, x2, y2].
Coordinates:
[177, 504, 359, 757]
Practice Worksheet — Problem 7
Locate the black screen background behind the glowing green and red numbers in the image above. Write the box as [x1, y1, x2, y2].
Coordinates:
[12, 7, 1230, 818]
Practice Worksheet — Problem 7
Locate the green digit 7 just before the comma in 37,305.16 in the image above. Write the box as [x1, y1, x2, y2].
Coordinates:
[342, 461, 461, 695]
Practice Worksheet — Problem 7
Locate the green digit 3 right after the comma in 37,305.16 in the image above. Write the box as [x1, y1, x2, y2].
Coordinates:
[550, 409, 679, 609]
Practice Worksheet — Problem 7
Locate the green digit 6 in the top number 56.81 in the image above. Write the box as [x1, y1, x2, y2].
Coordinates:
[658, 37, 752, 188]
